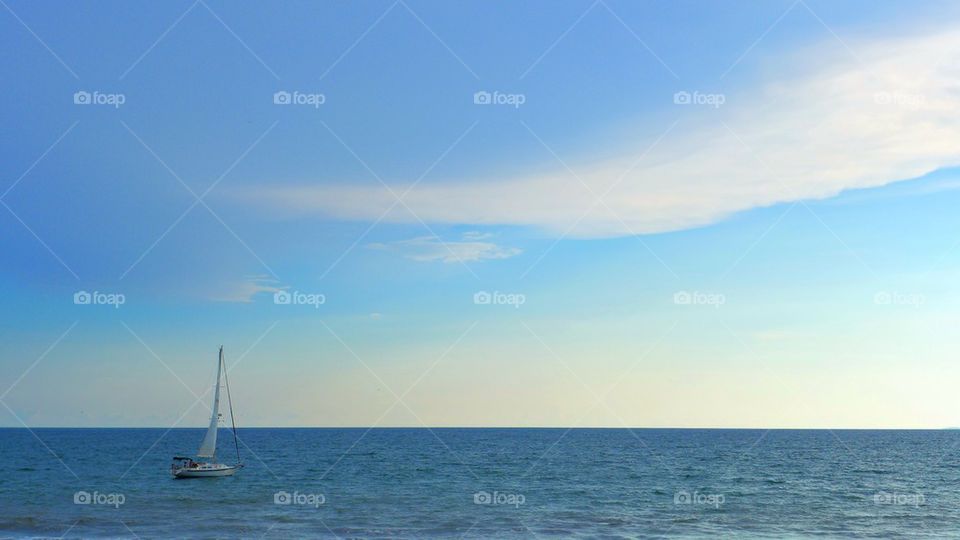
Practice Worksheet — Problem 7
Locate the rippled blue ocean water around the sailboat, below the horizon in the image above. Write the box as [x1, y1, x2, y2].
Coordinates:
[0, 428, 960, 538]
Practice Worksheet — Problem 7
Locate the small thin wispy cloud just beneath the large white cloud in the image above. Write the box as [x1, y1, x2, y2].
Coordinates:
[367, 232, 522, 263]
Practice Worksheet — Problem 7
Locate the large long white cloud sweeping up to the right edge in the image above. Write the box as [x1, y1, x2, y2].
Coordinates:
[236, 31, 960, 237]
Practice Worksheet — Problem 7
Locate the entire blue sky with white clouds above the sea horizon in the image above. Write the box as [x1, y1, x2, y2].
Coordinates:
[0, 0, 960, 428]
